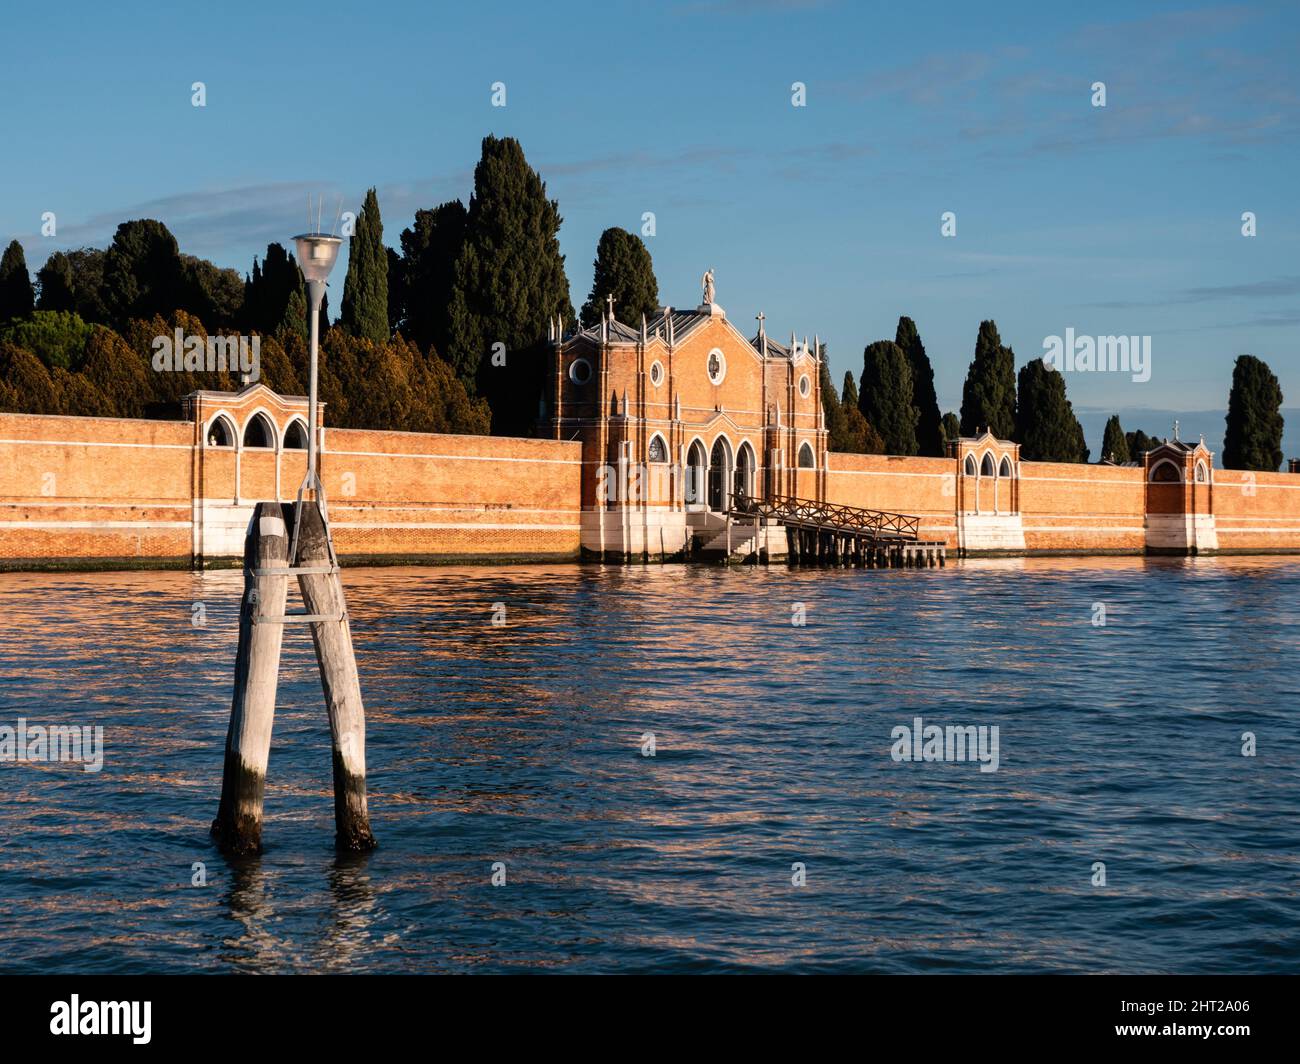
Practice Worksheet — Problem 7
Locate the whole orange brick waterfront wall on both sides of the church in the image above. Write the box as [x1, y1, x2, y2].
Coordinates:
[0, 403, 1300, 567]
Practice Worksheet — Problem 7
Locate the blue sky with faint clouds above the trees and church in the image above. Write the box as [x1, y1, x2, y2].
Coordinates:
[0, 0, 1300, 458]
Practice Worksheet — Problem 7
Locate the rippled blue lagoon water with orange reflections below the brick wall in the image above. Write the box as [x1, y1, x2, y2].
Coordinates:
[0, 558, 1300, 973]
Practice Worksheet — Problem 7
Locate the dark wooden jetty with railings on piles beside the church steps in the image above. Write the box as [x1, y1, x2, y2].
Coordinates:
[729, 496, 948, 568]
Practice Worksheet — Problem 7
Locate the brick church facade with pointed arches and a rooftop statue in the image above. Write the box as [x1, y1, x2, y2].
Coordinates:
[543, 286, 828, 558]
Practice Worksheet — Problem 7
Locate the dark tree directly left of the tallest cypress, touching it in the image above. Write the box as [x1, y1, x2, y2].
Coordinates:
[402, 199, 468, 358]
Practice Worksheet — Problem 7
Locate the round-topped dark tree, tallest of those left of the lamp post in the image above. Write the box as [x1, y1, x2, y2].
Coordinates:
[103, 219, 191, 332]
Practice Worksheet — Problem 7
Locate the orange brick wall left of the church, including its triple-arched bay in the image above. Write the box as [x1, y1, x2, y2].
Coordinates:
[0, 405, 581, 568]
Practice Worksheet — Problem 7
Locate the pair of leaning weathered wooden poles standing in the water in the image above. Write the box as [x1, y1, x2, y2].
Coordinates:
[212, 501, 374, 855]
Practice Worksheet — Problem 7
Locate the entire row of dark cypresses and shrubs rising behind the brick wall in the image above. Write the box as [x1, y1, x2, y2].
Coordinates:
[0, 135, 1282, 470]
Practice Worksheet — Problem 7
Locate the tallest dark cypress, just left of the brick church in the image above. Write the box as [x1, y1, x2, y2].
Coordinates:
[447, 135, 573, 413]
